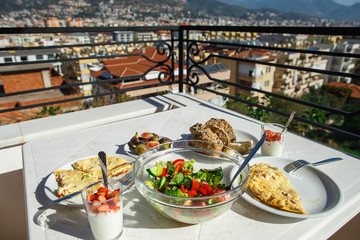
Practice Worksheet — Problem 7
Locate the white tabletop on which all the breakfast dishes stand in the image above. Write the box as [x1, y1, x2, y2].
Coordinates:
[23, 104, 360, 240]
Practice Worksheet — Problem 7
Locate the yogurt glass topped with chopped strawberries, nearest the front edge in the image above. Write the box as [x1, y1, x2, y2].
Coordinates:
[81, 181, 123, 240]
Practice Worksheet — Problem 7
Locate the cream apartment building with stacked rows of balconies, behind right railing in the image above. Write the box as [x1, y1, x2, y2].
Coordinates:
[273, 52, 328, 97]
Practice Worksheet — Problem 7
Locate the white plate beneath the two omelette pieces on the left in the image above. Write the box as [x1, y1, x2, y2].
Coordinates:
[44, 154, 134, 207]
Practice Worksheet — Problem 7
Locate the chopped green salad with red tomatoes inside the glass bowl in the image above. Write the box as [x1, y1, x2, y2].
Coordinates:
[144, 159, 230, 204]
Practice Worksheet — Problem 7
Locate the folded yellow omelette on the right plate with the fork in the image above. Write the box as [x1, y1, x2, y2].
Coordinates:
[249, 163, 307, 214]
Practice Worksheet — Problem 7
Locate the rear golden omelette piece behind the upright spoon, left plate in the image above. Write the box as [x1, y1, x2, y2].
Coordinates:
[72, 156, 132, 179]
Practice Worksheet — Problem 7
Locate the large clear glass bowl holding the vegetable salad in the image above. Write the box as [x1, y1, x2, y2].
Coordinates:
[133, 140, 250, 224]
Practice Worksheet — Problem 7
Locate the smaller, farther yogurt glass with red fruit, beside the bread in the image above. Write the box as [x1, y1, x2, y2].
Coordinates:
[261, 123, 287, 157]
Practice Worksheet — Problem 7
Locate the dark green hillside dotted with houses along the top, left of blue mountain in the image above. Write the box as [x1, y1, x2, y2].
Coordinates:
[0, 0, 320, 21]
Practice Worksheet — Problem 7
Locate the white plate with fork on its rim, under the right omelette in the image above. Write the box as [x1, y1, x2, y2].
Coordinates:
[242, 157, 343, 218]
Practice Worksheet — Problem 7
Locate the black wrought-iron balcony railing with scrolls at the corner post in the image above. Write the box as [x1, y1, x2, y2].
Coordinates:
[0, 26, 360, 145]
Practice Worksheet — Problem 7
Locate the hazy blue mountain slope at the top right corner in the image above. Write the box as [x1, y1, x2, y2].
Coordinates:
[219, 0, 360, 21]
